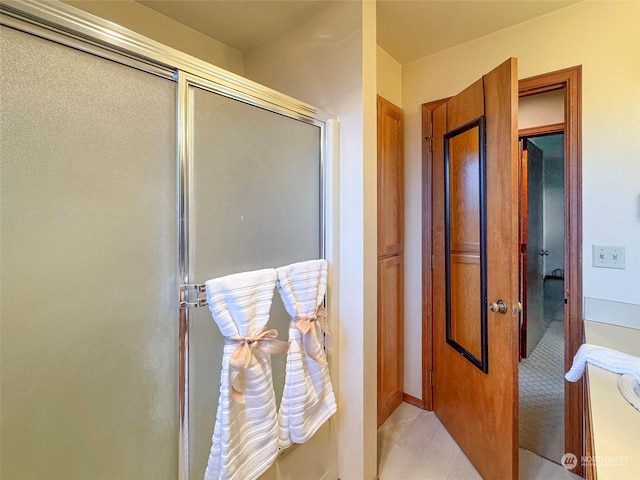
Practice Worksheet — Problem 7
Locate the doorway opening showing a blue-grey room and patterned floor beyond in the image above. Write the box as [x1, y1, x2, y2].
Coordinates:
[518, 128, 565, 463]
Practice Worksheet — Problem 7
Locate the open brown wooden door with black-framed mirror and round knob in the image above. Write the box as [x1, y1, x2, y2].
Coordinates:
[432, 58, 519, 479]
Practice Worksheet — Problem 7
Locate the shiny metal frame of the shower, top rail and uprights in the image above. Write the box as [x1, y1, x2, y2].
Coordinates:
[0, 0, 334, 480]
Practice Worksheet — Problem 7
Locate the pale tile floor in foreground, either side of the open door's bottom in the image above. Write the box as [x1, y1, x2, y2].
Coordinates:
[378, 403, 580, 480]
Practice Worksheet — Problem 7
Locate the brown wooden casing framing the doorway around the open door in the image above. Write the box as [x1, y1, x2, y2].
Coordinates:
[422, 65, 585, 475]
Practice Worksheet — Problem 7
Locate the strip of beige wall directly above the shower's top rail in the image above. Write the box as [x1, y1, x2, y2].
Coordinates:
[63, 0, 243, 75]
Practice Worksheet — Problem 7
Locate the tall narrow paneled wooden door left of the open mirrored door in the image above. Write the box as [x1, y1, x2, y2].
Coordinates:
[378, 97, 404, 426]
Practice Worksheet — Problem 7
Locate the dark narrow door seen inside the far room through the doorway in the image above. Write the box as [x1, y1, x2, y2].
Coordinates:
[520, 139, 546, 358]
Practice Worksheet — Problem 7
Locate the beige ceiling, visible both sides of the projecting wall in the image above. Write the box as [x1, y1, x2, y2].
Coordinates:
[138, 0, 578, 64]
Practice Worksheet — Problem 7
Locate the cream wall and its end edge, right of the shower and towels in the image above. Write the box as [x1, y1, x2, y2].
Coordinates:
[245, 2, 377, 480]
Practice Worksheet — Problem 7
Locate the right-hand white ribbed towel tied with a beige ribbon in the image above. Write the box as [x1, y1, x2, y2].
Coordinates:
[276, 260, 336, 448]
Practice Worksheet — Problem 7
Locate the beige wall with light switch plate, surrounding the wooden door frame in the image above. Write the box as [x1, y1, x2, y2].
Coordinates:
[402, 1, 640, 397]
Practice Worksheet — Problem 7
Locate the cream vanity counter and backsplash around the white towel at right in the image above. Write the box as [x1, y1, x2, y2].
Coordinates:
[585, 321, 640, 480]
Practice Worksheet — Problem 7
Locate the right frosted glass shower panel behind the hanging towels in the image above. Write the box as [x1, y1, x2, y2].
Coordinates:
[189, 88, 320, 479]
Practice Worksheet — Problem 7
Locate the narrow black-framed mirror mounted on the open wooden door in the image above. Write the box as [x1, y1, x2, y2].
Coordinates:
[444, 116, 488, 373]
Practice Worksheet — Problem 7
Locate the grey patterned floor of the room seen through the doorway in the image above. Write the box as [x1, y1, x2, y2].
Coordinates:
[519, 282, 564, 463]
